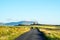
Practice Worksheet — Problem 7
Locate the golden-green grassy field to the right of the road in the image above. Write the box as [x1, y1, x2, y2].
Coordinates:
[39, 26, 60, 40]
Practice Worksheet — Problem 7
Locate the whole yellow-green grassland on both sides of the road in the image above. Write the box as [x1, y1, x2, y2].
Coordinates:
[0, 25, 60, 40]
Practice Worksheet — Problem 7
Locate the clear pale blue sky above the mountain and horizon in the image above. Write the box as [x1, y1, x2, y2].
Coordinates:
[0, 0, 60, 24]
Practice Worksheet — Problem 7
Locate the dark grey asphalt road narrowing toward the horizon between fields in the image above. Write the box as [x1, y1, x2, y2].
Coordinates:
[15, 28, 45, 40]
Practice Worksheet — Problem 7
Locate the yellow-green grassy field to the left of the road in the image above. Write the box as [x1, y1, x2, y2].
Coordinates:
[0, 26, 30, 40]
